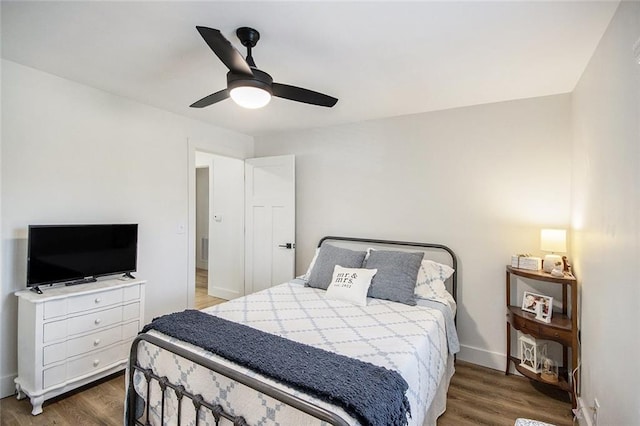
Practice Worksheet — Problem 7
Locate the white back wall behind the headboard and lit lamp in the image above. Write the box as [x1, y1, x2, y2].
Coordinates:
[255, 94, 571, 369]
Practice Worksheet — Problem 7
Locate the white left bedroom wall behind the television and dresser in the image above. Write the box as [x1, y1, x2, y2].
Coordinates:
[0, 61, 253, 396]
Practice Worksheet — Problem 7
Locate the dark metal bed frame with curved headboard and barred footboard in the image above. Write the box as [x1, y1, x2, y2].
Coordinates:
[125, 236, 457, 426]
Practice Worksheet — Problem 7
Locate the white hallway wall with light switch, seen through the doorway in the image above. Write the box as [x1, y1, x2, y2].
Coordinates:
[196, 151, 244, 299]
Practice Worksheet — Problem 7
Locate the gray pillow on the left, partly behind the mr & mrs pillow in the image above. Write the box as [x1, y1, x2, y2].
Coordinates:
[307, 244, 367, 290]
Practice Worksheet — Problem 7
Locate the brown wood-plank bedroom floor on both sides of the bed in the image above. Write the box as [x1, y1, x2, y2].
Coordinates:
[0, 361, 572, 426]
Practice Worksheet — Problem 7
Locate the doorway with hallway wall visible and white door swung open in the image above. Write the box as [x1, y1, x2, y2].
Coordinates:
[187, 140, 295, 307]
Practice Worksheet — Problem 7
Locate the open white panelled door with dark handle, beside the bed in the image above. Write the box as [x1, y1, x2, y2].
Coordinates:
[245, 155, 296, 294]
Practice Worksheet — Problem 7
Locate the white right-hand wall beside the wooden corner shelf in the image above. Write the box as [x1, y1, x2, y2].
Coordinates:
[572, 2, 640, 425]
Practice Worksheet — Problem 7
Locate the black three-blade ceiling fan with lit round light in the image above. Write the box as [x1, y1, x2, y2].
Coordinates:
[190, 27, 338, 108]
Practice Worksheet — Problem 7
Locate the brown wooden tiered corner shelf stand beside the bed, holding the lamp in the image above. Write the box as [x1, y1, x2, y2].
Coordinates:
[505, 266, 578, 408]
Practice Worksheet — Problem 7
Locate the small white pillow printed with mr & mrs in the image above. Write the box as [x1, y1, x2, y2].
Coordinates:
[327, 265, 378, 306]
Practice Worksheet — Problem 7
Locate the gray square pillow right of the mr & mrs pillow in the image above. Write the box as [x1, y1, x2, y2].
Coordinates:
[364, 250, 424, 305]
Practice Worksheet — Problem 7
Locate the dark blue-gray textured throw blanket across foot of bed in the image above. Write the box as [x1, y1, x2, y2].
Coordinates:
[142, 310, 411, 426]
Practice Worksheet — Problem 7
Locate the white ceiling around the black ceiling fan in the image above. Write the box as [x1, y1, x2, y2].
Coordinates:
[1, 0, 618, 135]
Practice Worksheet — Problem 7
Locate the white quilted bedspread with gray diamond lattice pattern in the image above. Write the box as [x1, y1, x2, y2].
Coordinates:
[134, 282, 456, 425]
